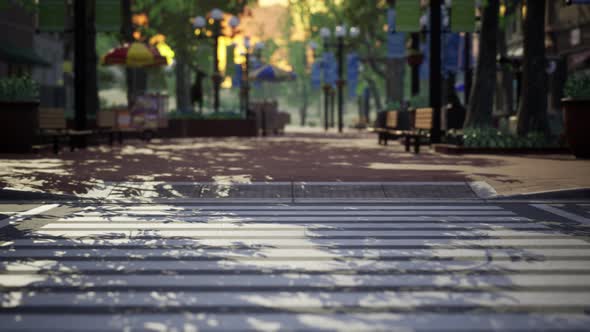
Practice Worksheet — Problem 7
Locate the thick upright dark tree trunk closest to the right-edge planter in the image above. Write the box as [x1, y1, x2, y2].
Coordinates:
[518, 0, 549, 136]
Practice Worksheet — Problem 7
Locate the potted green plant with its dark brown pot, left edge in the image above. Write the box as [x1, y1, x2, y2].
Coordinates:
[0, 76, 39, 152]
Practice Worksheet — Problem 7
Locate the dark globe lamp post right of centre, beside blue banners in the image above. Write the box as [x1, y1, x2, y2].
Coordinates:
[320, 25, 360, 133]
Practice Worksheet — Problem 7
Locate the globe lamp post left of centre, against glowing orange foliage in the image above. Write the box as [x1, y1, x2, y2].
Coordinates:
[193, 8, 240, 113]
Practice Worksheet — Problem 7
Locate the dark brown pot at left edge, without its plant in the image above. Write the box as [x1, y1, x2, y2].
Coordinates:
[0, 101, 39, 153]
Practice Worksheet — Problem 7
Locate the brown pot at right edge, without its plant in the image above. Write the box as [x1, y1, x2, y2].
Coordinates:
[561, 99, 590, 158]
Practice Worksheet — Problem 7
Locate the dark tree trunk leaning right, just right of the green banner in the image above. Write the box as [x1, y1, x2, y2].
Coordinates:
[465, 0, 499, 128]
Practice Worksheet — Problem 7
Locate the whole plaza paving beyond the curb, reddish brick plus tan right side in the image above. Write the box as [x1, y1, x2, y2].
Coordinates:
[0, 131, 590, 197]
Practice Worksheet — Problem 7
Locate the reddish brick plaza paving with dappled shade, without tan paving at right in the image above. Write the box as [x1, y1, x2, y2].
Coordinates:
[0, 135, 502, 197]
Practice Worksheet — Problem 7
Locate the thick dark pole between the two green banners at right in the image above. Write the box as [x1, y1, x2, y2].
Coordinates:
[430, 0, 442, 143]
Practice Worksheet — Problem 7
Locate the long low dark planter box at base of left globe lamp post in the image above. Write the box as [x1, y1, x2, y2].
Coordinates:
[159, 119, 256, 137]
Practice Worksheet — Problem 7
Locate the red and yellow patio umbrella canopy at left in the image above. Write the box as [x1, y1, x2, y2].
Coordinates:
[100, 42, 168, 67]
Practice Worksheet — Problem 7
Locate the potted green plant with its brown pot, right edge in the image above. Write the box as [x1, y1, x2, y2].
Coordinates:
[561, 74, 590, 158]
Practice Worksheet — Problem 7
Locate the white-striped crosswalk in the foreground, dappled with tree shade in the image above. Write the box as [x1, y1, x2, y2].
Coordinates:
[0, 202, 590, 331]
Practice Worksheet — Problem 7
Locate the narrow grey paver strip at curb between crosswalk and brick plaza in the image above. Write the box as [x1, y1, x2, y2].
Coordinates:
[98, 181, 496, 203]
